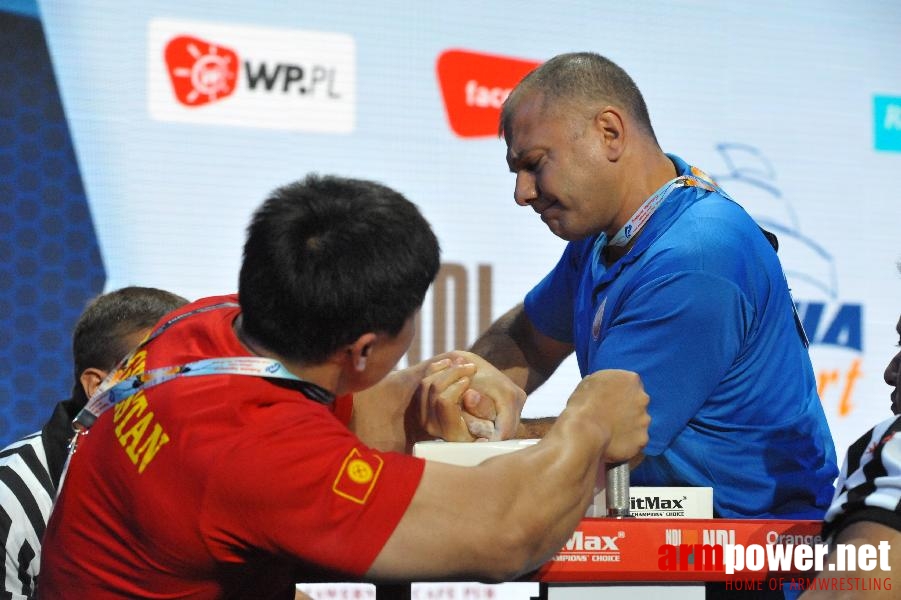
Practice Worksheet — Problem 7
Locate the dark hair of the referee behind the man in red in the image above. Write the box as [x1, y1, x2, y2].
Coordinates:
[72, 286, 188, 380]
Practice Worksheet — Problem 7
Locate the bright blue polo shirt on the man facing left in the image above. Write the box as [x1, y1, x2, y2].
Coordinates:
[525, 155, 838, 519]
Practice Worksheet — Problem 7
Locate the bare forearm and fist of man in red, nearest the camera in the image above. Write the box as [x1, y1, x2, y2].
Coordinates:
[369, 371, 650, 580]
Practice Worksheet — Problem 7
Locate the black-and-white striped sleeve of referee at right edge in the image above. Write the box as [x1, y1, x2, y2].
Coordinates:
[823, 416, 901, 539]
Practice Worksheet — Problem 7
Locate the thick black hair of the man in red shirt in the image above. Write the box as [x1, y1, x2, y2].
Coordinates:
[238, 174, 439, 364]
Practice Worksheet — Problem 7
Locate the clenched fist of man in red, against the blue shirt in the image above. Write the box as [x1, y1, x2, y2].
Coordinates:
[568, 369, 651, 463]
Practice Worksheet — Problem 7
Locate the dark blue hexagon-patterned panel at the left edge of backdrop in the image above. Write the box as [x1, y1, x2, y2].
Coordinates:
[0, 2, 106, 445]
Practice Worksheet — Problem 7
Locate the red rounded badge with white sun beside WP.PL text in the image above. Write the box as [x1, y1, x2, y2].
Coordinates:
[165, 35, 240, 106]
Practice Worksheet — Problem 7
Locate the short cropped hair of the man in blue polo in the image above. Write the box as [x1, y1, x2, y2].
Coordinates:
[499, 52, 657, 142]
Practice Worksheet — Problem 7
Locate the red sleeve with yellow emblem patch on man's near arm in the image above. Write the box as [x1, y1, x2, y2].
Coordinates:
[201, 397, 425, 575]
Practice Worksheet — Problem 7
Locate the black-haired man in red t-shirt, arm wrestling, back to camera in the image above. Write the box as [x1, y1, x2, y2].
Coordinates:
[38, 176, 649, 599]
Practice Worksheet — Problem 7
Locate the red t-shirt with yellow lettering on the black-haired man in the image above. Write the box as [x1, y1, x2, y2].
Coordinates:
[39, 296, 424, 599]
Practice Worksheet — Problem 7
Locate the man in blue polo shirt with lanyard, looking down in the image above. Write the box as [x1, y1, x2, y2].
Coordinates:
[473, 53, 838, 519]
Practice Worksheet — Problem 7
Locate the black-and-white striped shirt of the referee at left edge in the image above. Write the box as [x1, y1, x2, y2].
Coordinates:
[0, 433, 54, 600]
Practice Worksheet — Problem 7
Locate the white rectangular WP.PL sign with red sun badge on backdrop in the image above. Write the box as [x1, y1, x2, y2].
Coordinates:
[148, 19, 356, 133]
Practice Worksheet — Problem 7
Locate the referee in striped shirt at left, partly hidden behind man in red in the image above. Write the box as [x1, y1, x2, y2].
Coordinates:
[0, 287, 188, 600]
